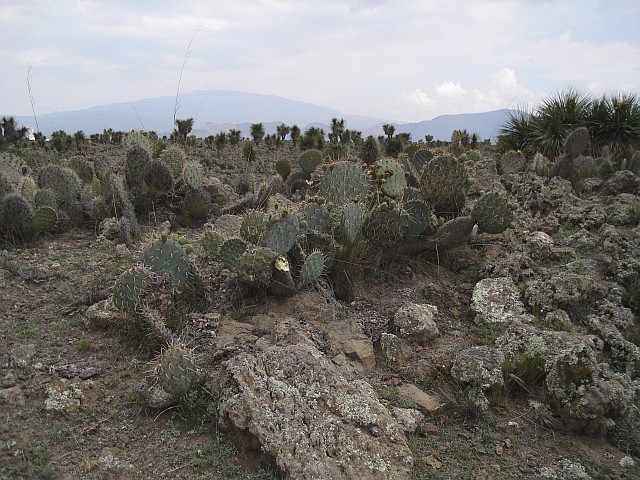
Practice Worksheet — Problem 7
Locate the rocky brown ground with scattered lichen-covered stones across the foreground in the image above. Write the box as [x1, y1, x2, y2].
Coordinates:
[0, 143, 640, 479]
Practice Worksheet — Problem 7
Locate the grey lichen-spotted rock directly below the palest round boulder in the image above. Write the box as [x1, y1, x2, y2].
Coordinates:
[451, 346, 504, 412]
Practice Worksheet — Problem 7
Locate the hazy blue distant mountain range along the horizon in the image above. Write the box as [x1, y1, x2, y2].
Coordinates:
[15, 90, 509, 141]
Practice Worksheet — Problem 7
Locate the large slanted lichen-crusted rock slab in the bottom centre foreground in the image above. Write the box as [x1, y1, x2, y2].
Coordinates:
[220, 344, 413, 479]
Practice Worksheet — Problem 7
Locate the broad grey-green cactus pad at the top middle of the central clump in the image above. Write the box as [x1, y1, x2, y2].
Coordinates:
[319, 162, 367, 205]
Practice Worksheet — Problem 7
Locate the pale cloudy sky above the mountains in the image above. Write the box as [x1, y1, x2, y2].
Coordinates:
[0, 0, 640, 122]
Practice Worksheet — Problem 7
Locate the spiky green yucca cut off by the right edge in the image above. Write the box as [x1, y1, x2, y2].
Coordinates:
[587, 93, 640, 162]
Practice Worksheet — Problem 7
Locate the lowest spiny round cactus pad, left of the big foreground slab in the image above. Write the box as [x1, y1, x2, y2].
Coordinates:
[157, 344, 199, 398]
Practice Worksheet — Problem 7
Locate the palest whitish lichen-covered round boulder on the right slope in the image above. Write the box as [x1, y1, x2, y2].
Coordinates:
[471, 277, 525, 323]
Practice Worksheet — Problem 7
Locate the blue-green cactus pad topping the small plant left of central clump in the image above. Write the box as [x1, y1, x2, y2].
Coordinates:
[142, 236, 192, 287]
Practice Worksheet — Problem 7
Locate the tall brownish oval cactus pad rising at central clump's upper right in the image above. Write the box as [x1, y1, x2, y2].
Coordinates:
[420, 154, 468, 214]
